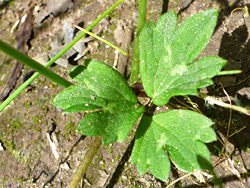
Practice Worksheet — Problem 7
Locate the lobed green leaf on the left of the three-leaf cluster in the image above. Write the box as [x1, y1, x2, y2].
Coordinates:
[52, 60, 144, 144]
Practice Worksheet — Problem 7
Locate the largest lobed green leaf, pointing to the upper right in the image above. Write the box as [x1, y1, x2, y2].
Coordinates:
[140, 10, 226, 105]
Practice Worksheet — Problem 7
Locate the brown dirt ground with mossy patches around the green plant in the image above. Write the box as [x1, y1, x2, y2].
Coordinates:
[0, 0, 250, 188]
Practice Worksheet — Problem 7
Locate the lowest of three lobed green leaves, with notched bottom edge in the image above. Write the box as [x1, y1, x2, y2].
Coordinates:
[131, 110, 216, 181]
